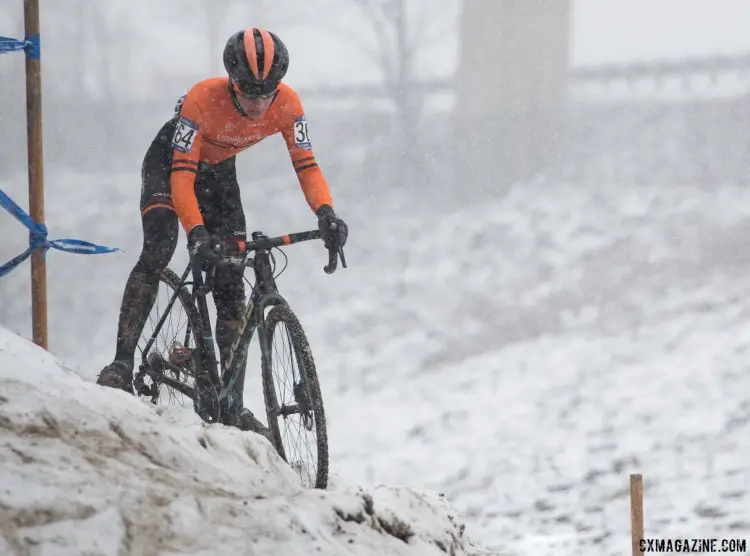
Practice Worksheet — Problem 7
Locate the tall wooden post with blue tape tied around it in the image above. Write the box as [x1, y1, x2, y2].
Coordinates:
[24, 0, 48, 349]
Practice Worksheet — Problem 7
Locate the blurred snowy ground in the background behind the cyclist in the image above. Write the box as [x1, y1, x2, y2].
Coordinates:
[0, 172, 750, 556]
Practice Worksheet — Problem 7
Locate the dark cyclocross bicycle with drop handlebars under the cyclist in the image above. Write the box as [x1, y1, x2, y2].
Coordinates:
[133, 225, 346, 489]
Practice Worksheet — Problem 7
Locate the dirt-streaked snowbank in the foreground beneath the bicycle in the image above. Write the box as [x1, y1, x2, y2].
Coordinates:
[0, 328, 488, 556]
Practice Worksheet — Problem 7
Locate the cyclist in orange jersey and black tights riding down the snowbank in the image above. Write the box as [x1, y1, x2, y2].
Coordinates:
[97, 28, 348, 433]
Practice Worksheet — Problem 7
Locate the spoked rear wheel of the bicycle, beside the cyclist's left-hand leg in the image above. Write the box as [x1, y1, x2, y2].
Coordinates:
[135, 268, 200, 407]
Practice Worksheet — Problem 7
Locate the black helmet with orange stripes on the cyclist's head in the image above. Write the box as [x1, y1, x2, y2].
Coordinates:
[224, 27, 289, 98]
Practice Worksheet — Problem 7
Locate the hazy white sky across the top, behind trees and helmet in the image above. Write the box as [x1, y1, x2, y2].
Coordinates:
[7, 0, 750, 96]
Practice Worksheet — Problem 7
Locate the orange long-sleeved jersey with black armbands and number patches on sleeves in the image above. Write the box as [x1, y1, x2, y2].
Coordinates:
[170, 77, 333, 232]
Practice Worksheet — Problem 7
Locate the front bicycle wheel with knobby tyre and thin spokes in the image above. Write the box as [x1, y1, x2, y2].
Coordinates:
[260, 305, 328, 489]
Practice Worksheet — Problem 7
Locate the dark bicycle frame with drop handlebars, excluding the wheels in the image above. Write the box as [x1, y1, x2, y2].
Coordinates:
[136, 226, 346, 422]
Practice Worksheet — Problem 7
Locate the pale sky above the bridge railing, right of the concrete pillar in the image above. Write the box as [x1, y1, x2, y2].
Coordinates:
[571, 0, 750, 65]
